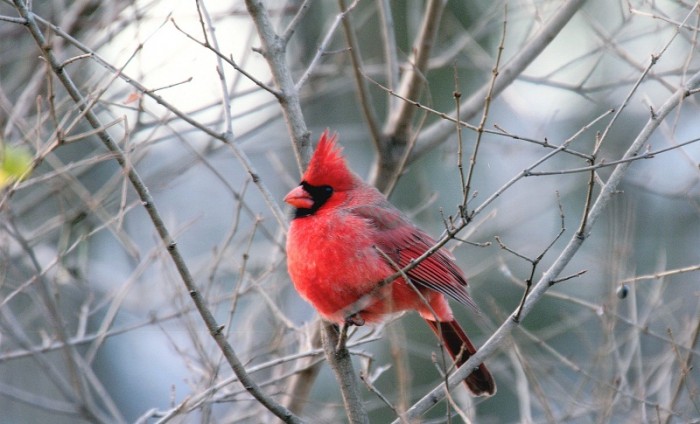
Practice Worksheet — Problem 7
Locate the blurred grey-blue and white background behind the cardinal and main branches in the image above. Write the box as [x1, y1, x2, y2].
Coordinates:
[0, 0, 700, 423]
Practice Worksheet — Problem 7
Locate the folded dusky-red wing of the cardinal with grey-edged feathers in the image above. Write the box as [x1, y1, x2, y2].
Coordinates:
[352, 201, 477, 309]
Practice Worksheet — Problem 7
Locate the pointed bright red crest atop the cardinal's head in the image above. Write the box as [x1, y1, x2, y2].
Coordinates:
[304, 130, 356, 190]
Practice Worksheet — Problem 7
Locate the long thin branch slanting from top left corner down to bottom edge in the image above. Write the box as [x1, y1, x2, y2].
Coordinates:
[14, 0, 301, 423]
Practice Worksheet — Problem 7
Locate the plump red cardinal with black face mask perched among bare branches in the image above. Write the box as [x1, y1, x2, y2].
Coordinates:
[284, 131, 496, 395]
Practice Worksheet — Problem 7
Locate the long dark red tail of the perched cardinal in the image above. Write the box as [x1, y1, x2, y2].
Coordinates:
[425, 319, 496, 396]
